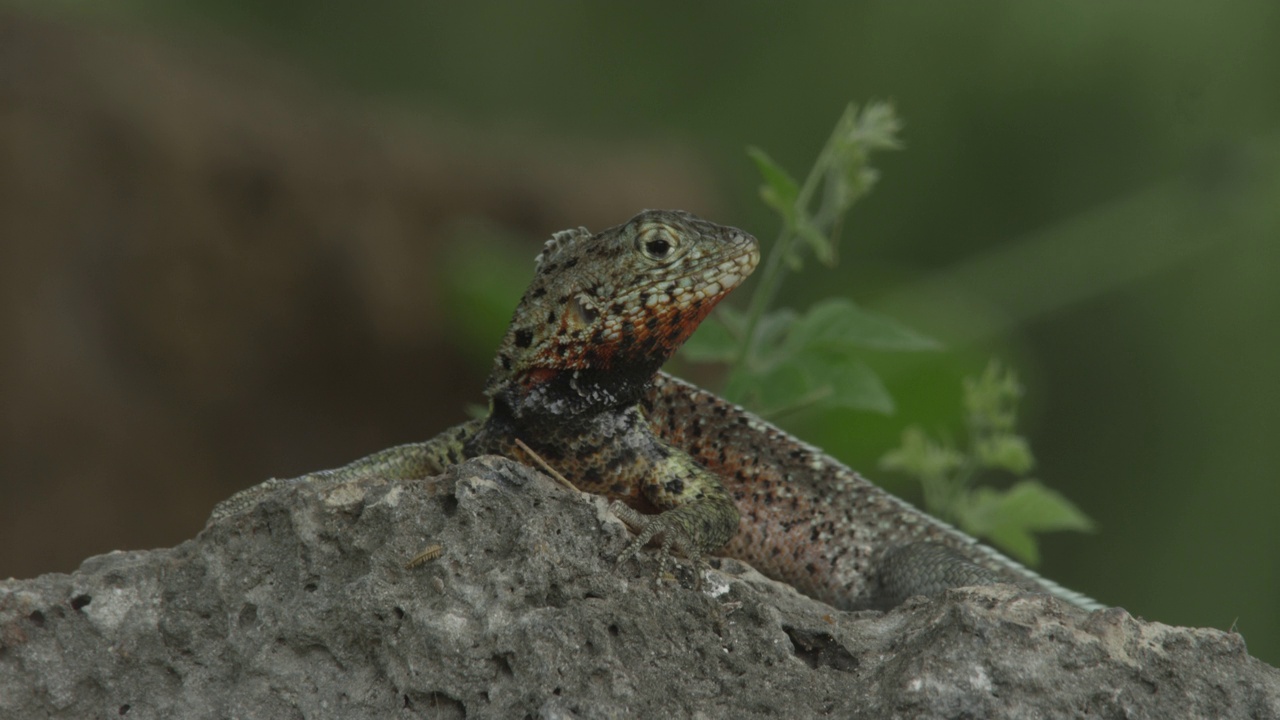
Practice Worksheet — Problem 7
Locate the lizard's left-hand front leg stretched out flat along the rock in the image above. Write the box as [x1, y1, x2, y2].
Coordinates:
[209, 420, 483, 523]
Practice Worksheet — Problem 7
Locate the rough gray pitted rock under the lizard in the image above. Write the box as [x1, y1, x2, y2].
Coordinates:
[0, 457, 1280, 719]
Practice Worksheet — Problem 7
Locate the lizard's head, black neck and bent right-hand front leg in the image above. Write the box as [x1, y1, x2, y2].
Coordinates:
[463, 210, 759, 561]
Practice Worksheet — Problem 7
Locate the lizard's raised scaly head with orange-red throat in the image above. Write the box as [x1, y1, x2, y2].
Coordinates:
[485, 210, 760, 415]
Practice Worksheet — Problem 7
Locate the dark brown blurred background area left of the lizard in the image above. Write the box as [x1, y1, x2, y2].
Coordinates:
[0, 13, 714, 578]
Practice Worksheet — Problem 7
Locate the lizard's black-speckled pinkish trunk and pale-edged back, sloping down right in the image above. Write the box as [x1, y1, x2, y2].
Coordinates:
[641, 373, 1102, 610]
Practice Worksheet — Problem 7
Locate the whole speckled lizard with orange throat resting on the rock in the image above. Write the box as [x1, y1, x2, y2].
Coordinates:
[210, 210, 1102, 610]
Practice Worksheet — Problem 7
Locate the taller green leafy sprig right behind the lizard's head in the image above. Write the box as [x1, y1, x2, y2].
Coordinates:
[684, 104, 938, 416]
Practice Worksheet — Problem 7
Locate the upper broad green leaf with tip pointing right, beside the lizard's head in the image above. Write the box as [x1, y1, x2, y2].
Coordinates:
[791, 299, 941, 351]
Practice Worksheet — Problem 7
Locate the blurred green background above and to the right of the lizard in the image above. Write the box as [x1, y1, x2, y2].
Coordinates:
[0, 0, 1280, 664]
